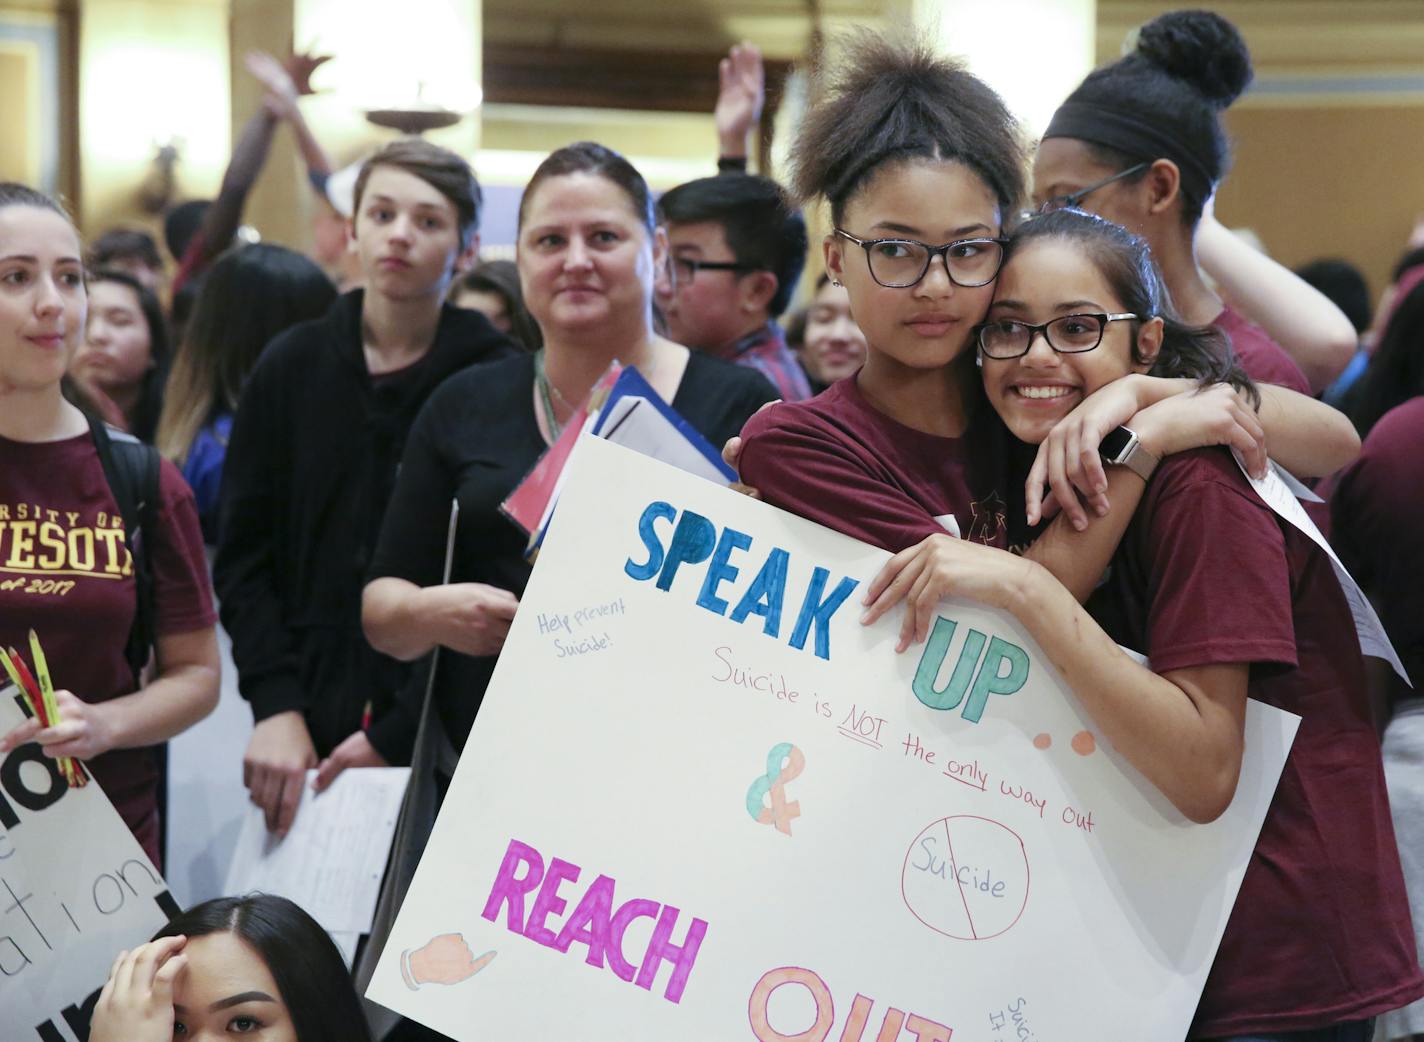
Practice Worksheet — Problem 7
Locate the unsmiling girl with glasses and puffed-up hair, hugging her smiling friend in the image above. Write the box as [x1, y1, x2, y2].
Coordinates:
[740, 34, 1358, 599]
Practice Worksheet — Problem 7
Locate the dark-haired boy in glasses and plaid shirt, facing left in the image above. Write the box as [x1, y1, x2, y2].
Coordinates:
[658, 174, 810, 401]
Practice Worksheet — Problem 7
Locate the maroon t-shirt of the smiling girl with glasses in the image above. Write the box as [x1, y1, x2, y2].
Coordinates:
[1089, 448, 1424, 1038]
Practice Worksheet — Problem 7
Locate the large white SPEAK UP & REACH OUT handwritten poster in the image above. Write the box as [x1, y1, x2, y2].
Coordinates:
[367, 441, 1297, 1042]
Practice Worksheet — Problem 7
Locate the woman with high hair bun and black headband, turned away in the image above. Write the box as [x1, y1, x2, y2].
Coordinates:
[1034, 11, 1356, 394]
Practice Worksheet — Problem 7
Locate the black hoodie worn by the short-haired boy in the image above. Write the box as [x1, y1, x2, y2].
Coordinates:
[214, 290, 518, 763]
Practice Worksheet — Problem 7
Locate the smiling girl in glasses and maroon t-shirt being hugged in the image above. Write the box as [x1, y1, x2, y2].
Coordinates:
[867, 211, 1424, 1042]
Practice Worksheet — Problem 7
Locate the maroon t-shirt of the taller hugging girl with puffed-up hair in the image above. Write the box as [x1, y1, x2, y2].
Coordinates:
[738, 376, 1027, 552]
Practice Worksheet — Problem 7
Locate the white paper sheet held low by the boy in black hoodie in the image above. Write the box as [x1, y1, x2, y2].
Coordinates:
[226, 767, 410, 934]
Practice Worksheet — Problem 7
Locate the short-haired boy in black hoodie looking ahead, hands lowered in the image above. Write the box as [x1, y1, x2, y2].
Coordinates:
[214, 140, 514, 833]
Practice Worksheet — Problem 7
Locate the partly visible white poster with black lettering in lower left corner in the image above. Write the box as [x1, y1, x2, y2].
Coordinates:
[0, 686, 178, 1042]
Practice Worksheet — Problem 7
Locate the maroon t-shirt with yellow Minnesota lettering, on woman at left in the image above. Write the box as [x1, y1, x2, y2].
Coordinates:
[0, 431, 216, 864]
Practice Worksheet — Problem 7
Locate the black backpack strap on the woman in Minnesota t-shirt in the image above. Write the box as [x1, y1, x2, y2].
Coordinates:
[90, 417, 159, 689]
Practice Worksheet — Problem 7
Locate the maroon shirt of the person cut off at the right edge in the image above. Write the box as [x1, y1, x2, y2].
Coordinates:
[1330, 397, 1424, 699]
